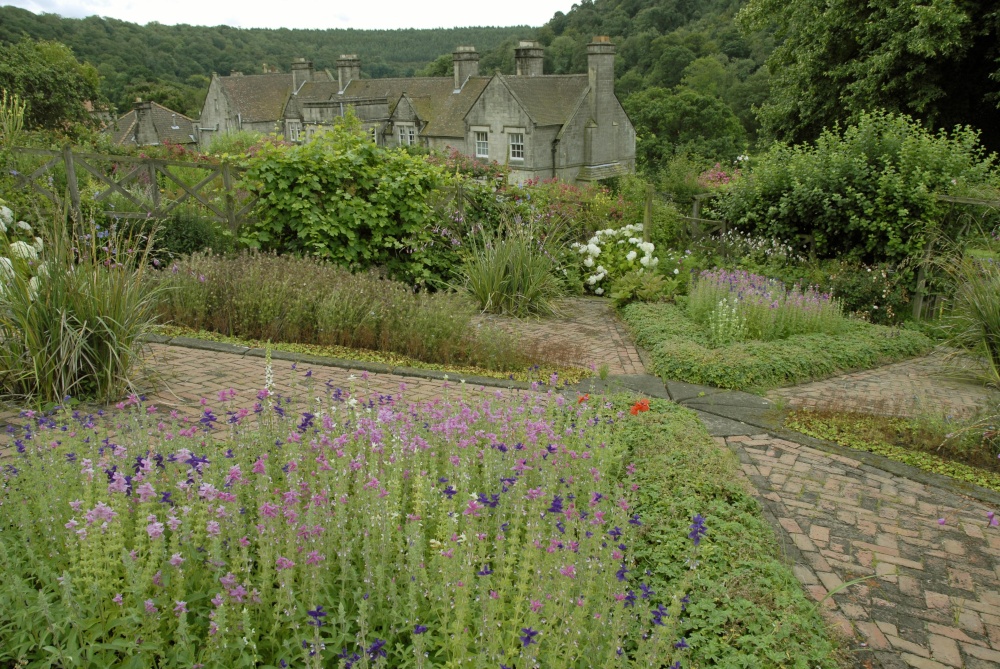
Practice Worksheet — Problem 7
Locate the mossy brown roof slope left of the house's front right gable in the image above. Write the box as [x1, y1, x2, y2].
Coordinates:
[344, 77, 491, 137]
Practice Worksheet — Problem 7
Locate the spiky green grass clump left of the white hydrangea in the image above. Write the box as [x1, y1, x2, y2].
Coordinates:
[461, 216, 565, 317]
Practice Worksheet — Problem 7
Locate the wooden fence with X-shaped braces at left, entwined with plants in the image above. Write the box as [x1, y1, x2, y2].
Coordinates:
[13, 146, 257, 230]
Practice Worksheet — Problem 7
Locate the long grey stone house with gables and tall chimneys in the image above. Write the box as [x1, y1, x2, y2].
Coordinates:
[195, 37, 635, 183]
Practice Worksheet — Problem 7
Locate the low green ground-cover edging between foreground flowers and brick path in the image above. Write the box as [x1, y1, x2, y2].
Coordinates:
[619, 400, 840, 669]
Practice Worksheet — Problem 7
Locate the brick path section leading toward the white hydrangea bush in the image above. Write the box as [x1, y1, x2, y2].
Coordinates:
[481, 297, 645, 375]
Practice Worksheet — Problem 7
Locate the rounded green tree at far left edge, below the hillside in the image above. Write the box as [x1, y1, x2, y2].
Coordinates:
[0, 39, 101, 129]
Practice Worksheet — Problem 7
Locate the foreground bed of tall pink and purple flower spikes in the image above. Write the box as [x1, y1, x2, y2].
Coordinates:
[0, 372, 705, 669]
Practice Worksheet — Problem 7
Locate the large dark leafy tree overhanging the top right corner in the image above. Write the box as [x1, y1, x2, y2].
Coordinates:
[739, 0, 1000, 148]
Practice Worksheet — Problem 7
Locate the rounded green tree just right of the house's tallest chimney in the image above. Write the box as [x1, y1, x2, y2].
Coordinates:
[625, 87, 746, 169]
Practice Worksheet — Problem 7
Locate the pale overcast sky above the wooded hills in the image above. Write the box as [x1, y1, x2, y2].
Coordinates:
[0, 0, 573, 28]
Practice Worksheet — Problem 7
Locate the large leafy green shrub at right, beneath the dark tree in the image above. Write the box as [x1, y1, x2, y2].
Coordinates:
[713, 112, 996, 262]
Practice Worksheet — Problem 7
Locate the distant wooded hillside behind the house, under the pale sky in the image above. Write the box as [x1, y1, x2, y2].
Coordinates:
[0, 6, 536, 117]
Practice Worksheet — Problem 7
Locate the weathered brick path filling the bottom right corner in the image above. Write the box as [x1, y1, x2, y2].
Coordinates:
[718, 435, 1000, 669]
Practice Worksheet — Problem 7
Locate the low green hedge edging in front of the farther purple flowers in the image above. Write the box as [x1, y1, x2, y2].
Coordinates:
[621, 303, 932, 389]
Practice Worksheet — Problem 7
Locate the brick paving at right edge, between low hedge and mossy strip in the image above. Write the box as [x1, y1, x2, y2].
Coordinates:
[768, 351, 1000, 418]
